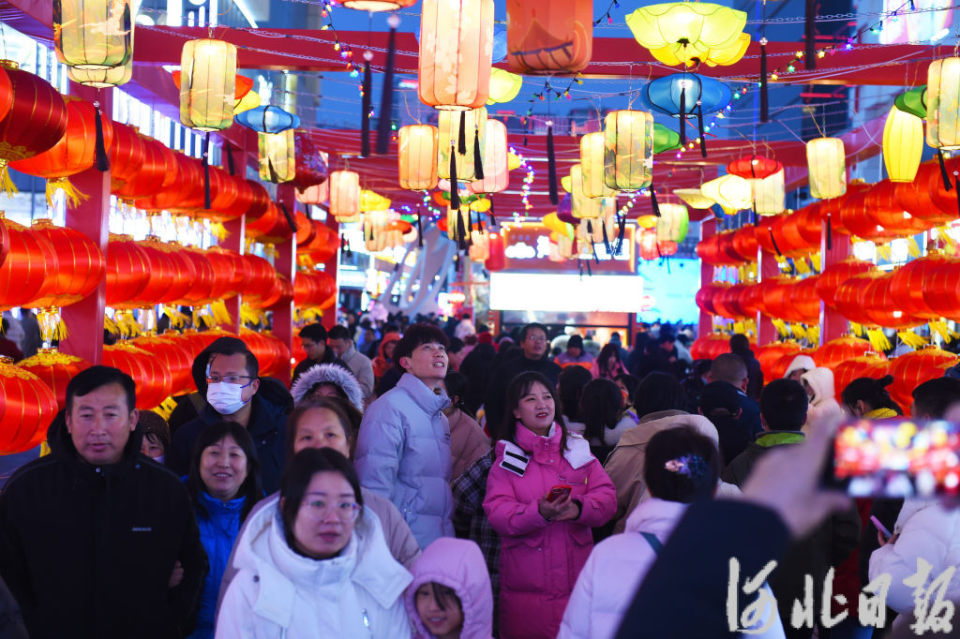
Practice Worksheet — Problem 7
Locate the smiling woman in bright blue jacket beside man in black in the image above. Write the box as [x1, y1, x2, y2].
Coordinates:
[187, 422, 263, 639]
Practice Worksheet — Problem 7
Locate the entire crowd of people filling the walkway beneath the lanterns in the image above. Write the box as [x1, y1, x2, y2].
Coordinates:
[0, 315, 960, 639]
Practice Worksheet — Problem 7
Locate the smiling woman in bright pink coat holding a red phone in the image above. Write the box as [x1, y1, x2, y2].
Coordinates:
[483, 372, 617, 639]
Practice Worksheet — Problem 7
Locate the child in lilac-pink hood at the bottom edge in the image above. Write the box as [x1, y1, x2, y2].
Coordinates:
[403, 537, 493, 639]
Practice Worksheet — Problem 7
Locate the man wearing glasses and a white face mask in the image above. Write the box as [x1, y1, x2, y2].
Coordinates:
[166, 337, 292, 493]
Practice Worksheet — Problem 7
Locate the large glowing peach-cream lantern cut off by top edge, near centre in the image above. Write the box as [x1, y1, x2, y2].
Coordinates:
[418, 0, 493, 111]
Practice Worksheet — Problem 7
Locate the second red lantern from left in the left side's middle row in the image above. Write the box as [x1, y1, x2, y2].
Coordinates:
[31, 220, 107, 308]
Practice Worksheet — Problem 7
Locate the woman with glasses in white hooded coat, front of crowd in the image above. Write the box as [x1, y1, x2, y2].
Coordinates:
[216, 448, 411, 639]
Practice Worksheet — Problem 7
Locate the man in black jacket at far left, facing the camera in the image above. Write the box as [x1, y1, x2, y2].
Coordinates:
[0, 366, 207, 639]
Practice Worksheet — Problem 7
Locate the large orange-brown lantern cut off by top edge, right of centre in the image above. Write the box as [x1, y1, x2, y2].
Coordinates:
[507, 0, 593, 75]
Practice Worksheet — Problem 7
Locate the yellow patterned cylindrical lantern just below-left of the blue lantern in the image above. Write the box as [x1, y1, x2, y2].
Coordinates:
[603, 111, 653, 191]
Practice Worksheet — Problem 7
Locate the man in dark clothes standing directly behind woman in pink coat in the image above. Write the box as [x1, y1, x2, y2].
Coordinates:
[483, 322, 560, 441]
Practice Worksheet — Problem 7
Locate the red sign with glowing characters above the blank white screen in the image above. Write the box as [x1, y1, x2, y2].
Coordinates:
[502, 223, 636, 275]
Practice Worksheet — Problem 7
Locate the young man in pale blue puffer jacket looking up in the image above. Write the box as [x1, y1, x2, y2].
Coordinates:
[354, 324, 453, 548]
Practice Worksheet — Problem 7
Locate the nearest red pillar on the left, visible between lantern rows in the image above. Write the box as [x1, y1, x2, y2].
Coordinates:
[60, 82, 113, 364]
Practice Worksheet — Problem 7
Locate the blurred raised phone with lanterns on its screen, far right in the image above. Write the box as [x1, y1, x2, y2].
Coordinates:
[833, 417, 960, 497]
